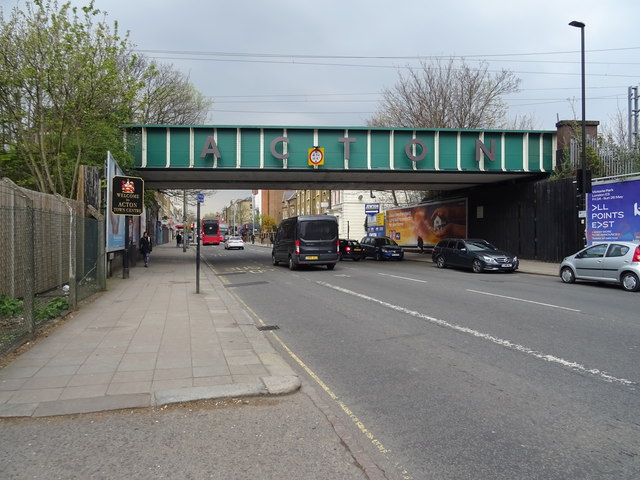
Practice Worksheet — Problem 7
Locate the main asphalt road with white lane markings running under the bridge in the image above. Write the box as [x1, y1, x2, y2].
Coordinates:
[203, 246, 640, 479]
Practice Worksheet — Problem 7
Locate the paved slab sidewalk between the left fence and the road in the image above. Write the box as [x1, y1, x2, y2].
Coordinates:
[0, 244, 300, 417]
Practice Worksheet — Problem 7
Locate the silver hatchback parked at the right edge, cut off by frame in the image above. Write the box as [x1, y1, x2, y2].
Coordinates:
[560, 242, 640, 292]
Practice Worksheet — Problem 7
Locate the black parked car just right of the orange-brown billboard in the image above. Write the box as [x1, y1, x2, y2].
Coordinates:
[431, 238, 519, 273]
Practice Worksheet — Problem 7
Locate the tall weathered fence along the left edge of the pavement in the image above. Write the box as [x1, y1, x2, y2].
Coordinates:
[0, 179, 106, 355]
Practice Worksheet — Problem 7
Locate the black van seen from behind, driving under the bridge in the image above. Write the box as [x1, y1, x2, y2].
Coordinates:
[271, 215, 339, 270]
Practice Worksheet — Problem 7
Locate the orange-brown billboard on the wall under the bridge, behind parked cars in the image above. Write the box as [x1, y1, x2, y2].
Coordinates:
[386, 198, 467, 245]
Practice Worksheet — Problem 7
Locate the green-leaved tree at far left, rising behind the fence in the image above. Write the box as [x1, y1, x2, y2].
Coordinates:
[0, 0, 139, 197]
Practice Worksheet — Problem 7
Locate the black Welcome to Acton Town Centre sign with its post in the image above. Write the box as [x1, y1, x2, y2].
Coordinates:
[111, 175, 144, 278]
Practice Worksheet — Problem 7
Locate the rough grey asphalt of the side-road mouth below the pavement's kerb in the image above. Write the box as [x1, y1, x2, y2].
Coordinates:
[0, 392, 368, 480]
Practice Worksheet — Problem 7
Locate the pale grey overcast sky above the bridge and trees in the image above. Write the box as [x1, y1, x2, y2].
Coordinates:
[0, 0, 640, 210]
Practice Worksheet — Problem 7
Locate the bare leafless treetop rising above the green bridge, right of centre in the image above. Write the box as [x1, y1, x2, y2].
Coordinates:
[368, 59, 520, 128]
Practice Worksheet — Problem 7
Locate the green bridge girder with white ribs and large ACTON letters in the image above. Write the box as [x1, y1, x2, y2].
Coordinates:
[125, 125, 556, 189]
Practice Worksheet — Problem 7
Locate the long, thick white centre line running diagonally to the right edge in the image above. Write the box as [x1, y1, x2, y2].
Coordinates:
[317, 282, 636, 387]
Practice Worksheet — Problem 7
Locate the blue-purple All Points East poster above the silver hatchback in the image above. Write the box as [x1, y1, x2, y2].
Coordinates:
[587, 180, 640, 245]
